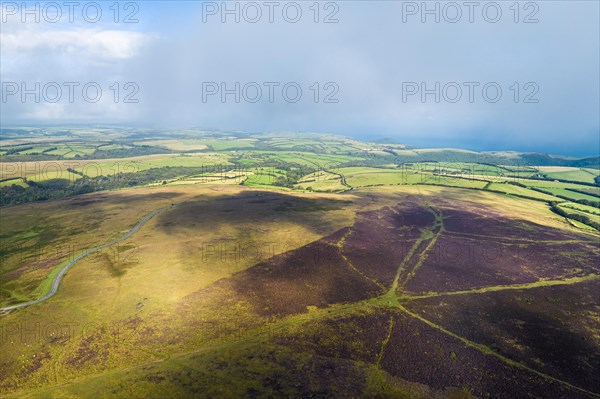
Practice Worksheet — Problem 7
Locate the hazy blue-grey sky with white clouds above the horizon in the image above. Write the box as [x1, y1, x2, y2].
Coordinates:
[0, 0, 600, 156]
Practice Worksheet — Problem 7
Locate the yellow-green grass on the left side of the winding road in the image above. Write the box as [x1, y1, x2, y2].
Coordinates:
[0, 190, 180, 305]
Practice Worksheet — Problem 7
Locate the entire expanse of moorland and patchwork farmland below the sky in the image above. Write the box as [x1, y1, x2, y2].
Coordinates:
[0, 126, 600, 398]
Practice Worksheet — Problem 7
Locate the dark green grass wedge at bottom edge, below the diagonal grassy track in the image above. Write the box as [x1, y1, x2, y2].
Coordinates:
[3, 303, 446, 399]
